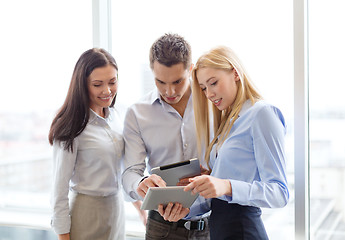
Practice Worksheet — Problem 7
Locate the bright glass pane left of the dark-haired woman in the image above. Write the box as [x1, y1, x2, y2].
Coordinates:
[0, 0, 92, 230]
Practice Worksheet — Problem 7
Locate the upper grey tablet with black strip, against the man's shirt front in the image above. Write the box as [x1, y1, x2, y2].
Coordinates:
[151, 158, 200, 186]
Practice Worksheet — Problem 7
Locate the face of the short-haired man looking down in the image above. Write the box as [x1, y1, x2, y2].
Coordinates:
[153, 61, 190, 105]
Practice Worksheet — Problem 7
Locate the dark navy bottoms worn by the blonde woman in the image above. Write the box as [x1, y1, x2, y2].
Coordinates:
[209, 198, 268, 240]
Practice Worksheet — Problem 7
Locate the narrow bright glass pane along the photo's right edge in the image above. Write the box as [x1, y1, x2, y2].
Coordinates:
[309, 0, 345, 240]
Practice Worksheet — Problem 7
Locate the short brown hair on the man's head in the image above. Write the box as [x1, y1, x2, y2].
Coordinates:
[150, 33, 192, 69]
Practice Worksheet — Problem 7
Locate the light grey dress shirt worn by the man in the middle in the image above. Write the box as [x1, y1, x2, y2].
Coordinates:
[122, 89, 203, 200]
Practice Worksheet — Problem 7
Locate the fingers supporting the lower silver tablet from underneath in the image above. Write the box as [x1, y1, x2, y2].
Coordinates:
[158, 203, 189, 222]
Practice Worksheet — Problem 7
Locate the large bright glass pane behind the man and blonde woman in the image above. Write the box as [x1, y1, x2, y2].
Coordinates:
[112, 0, 294, 240]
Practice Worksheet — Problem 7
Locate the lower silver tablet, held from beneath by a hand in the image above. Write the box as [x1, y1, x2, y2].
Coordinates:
[141, 186, 199, 210]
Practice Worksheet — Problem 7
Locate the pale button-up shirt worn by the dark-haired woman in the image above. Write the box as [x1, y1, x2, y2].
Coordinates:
[51, 108, 124, 234]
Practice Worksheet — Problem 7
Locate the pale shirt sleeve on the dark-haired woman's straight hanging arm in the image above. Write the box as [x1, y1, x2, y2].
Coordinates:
[51, 140, 78, 237]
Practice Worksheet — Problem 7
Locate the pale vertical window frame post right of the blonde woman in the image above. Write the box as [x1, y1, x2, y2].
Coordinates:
[293, 0, 310, 240]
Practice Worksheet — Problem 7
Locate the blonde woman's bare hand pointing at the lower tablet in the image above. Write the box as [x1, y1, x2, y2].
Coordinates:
[184, 175, 232, 198]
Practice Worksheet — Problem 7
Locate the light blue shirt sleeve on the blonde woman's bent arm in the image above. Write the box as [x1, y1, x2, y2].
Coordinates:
[228, 107, 289, 208]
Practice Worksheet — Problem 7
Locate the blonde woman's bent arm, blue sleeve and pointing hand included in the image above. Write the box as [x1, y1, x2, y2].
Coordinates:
[185, 107, 289, 207]
